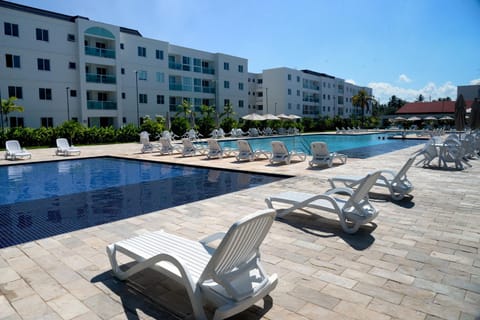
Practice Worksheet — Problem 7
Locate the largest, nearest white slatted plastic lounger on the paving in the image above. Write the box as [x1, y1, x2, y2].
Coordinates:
[107, 210, 278, 319]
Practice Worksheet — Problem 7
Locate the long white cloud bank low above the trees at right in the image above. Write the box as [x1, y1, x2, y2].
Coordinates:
[368, 82, 457, 103]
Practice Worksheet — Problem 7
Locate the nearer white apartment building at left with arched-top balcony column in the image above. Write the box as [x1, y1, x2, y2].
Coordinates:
[0, 1, 248, 128]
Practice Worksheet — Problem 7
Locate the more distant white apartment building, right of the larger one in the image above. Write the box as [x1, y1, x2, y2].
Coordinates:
[248, 68, 372, 118]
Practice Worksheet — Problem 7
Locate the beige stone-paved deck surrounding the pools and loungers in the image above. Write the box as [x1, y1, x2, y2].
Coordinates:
[0, 138, 480, 320]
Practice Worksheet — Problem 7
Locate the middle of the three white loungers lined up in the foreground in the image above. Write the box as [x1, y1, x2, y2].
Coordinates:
[265, 172, 380, 233]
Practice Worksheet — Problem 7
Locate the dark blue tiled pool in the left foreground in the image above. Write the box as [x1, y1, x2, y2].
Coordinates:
[0, 158, 282, 248]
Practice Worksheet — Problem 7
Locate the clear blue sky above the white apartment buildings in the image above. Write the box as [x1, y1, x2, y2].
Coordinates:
[11, 0, 480, 103]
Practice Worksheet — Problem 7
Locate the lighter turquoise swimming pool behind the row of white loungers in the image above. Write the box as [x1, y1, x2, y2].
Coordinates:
[220, 133, 425, 159]
